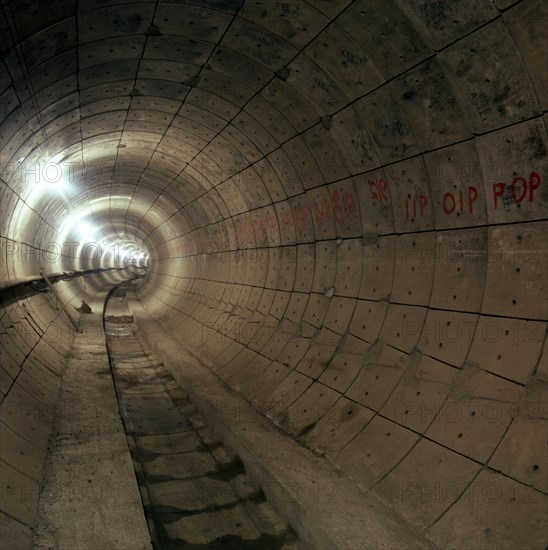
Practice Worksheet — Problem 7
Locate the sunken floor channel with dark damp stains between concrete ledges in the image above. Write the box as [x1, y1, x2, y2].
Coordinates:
[104, 283, 304, 550]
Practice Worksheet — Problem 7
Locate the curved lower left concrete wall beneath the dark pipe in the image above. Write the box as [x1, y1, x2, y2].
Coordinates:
[0, 270, 136, 549]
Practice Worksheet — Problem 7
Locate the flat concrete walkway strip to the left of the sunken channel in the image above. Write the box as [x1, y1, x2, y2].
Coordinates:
[32, 314, 152, 550]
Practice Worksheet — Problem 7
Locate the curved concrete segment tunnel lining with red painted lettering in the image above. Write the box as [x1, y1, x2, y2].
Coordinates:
[0, 0, 548, 548]
